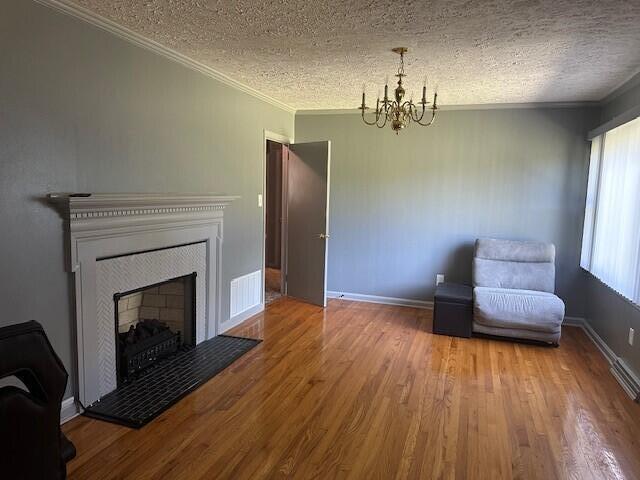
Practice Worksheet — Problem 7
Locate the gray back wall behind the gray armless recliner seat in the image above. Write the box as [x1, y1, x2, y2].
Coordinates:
[296, 108, 599, 316]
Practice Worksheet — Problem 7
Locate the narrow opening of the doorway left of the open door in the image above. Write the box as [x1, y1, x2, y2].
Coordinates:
[264, 139, 286, 304]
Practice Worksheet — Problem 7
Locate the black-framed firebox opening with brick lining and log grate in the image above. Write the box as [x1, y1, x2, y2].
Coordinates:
[113, 272, 197, 385]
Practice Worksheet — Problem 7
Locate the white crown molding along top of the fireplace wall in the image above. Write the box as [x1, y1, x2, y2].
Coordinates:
[34, 0, 296, 114]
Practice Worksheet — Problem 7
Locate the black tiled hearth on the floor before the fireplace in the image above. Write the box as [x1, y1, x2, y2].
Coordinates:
[84, 335, 260, 428]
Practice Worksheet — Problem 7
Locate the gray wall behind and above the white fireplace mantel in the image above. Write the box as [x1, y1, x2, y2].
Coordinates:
[0, 0, 294, 398]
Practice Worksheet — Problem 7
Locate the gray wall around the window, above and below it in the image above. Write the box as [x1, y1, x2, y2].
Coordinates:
[584, 74, 640, 377]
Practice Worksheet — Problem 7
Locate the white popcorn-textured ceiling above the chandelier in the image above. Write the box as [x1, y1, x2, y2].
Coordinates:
[68, 0, 640, 109]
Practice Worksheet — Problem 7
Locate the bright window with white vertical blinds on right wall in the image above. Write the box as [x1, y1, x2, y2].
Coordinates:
[580, 117, 640, 304]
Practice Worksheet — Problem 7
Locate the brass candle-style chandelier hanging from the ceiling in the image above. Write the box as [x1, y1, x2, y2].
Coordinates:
[358, 47, 438, 135]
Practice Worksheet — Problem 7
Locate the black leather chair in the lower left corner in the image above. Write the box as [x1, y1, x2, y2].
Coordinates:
[0, 321, 76, 480]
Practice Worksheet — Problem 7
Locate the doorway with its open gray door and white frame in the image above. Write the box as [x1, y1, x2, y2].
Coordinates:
[258, 130, 331, 307]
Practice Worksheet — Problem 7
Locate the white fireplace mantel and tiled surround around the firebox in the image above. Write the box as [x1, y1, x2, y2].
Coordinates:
[50, 194, 237, 405]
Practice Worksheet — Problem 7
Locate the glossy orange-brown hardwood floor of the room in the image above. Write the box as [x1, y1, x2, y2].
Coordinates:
[64, 299, 640, 479]
